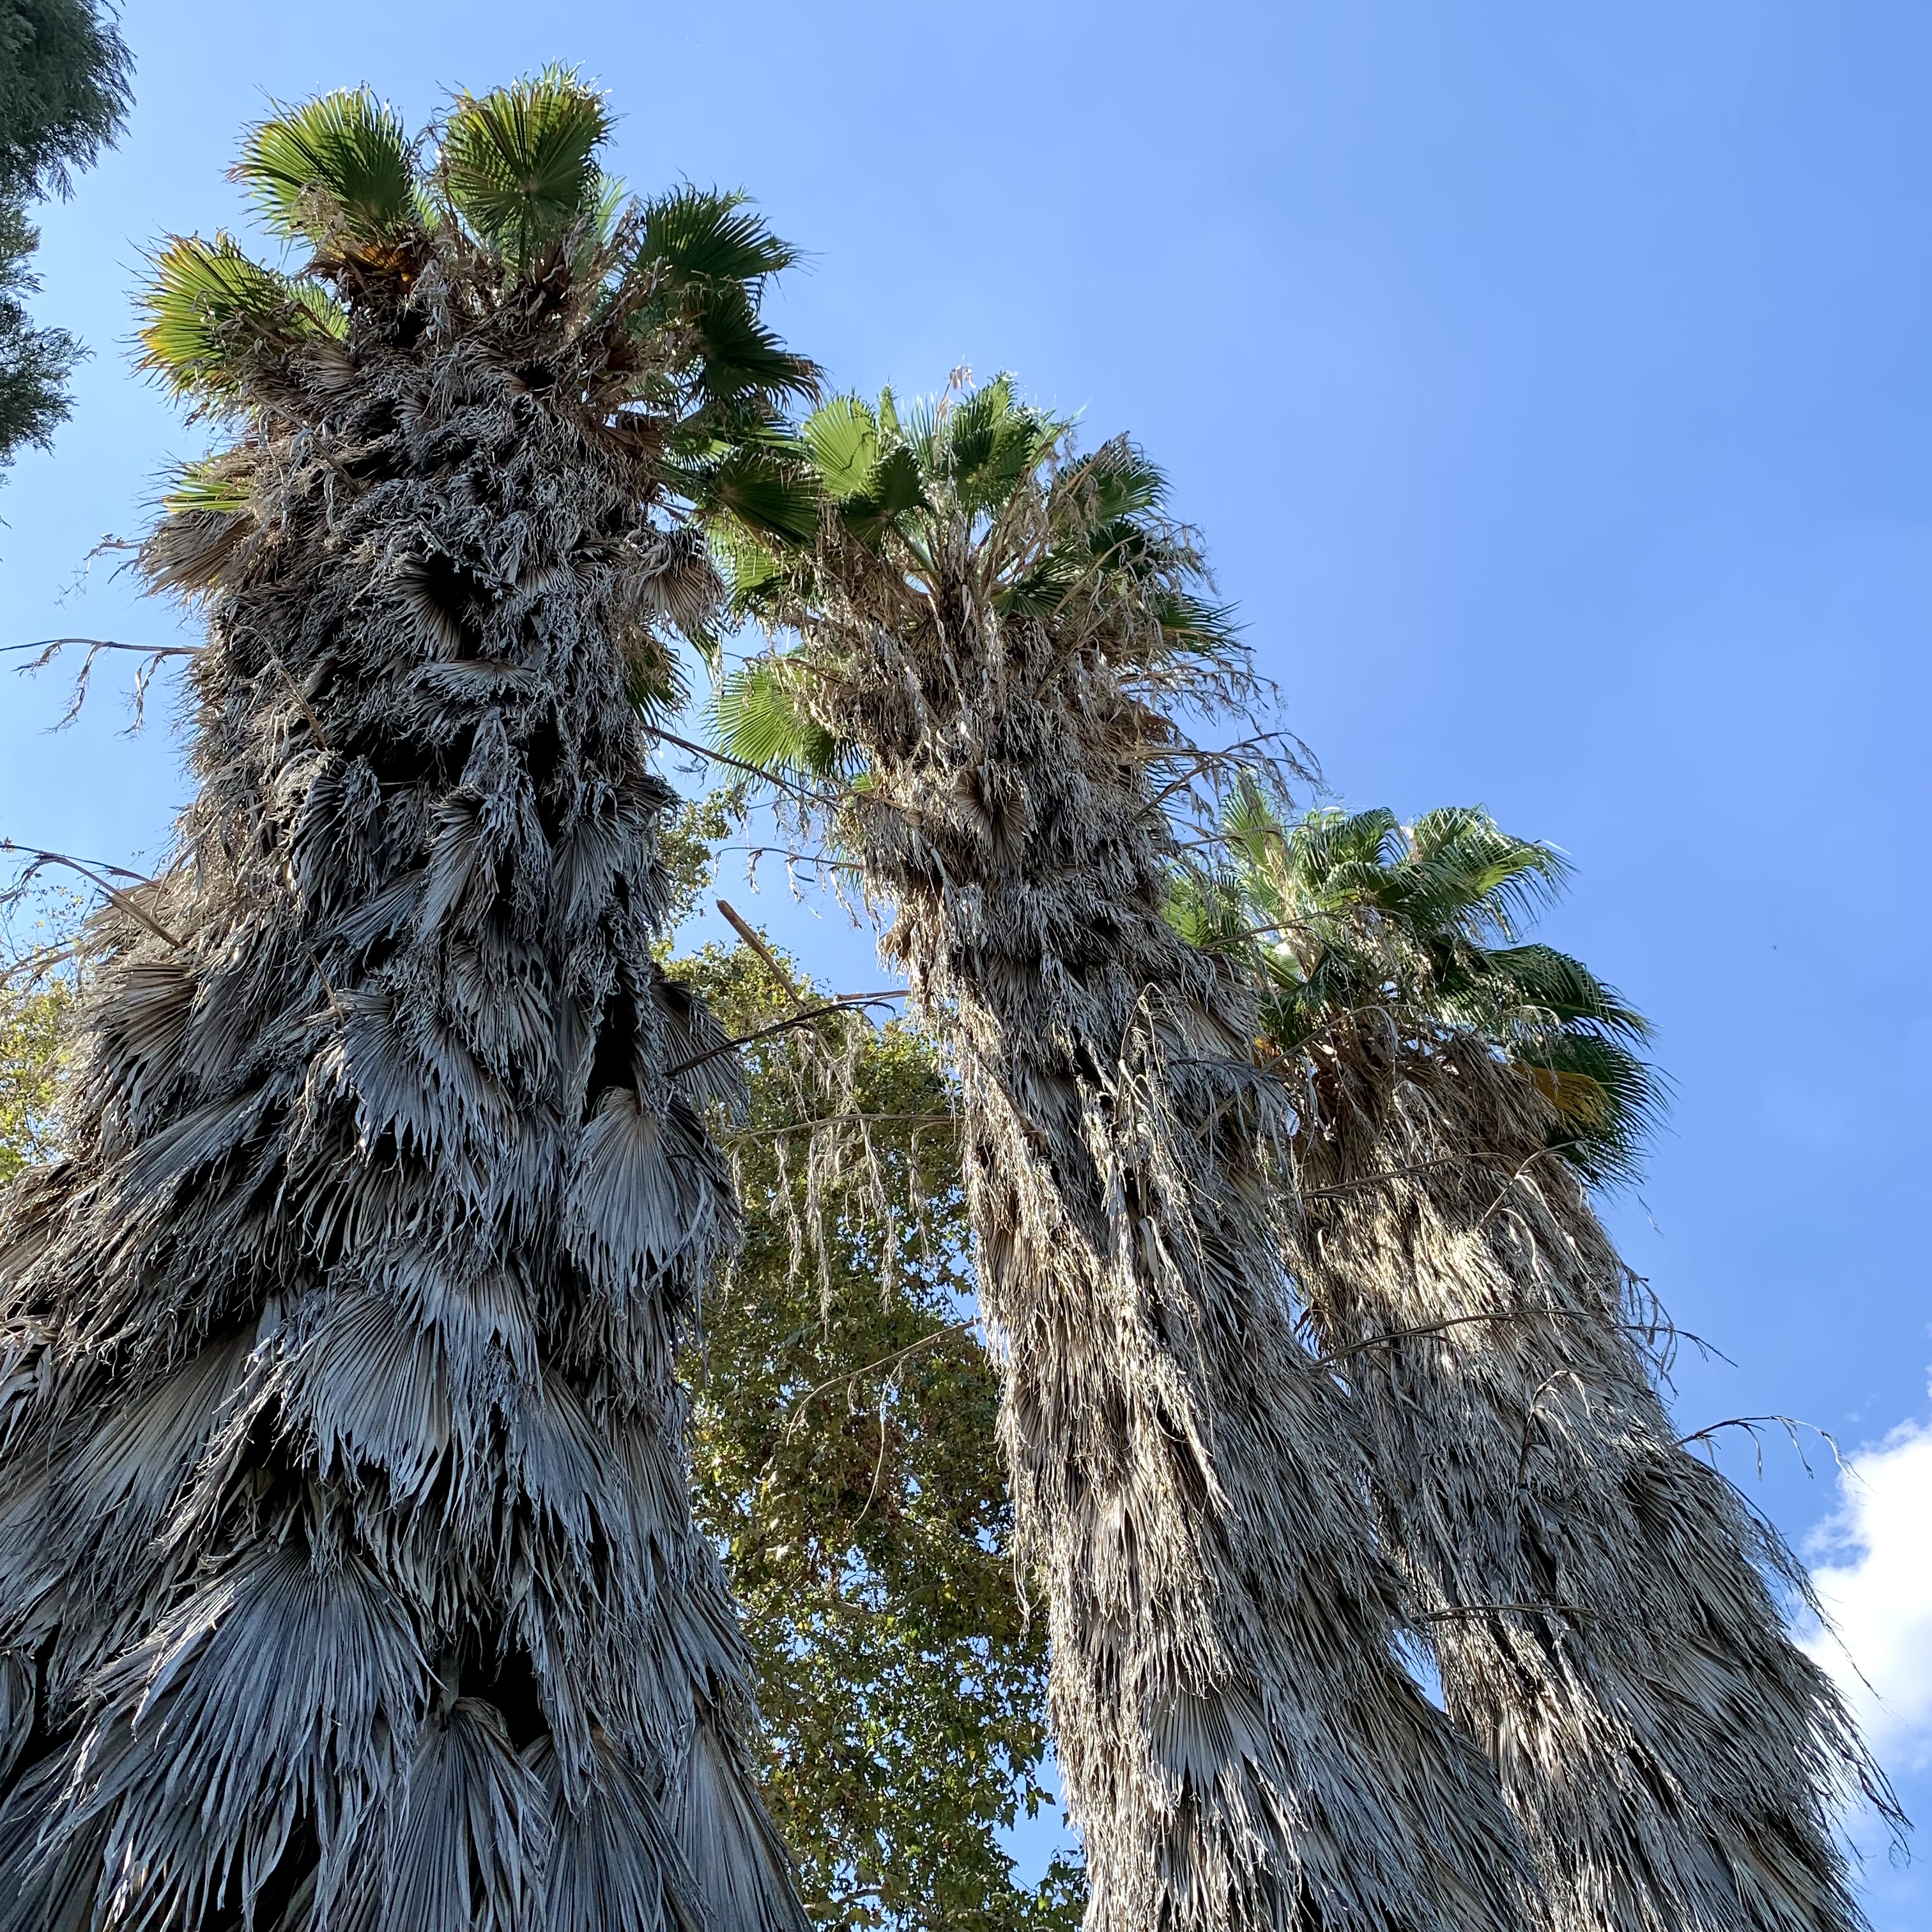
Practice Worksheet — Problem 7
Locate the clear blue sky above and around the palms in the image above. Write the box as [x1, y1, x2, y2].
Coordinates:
[0, 0, 1932, 1932]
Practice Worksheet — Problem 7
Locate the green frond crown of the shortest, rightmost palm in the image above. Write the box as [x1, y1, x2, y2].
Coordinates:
[1175, 779, 1666, 1184]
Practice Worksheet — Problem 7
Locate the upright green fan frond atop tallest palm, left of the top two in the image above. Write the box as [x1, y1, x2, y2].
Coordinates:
[230, 87, 419, 245]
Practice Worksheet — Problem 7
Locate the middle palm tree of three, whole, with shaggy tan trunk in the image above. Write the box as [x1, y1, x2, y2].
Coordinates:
[703, 379, 1515, 1932]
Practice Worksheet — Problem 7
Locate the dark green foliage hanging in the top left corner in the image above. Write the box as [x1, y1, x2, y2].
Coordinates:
[0, 0, 132, 466]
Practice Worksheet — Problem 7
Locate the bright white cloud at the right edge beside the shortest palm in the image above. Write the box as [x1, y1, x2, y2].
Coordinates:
[1806, 1422, 1932, 1772]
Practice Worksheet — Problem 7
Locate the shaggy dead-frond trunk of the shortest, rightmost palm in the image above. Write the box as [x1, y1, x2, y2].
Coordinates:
[1298, 1030, 1885, 1932]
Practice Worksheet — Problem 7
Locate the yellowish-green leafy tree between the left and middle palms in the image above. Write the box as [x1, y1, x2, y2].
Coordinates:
[672, 927, 1084, 1932]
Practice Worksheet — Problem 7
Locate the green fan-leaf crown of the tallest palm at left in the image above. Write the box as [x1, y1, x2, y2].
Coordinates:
[141, 66, 817, 475]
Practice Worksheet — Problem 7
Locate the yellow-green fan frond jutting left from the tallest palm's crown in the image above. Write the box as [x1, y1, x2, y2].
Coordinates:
[139, 234, 348, 408]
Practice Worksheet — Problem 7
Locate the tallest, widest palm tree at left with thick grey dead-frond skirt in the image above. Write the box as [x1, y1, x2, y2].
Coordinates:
[0, 72, 811, 1932]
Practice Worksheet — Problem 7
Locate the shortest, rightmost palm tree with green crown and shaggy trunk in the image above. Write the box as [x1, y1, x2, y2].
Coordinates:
[1181, 786, 1889, 1932]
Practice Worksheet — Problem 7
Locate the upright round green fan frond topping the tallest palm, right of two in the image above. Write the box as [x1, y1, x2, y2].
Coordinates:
[440, 68, 611, 274]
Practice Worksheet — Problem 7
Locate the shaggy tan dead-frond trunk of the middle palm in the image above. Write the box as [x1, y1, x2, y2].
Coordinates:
[813, 595, 1517, 1932]
